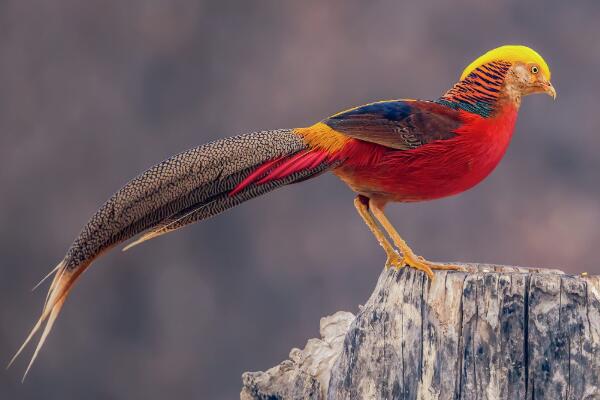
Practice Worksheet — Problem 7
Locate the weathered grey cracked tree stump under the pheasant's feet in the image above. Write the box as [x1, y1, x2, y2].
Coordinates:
[240, 265, 600, 400]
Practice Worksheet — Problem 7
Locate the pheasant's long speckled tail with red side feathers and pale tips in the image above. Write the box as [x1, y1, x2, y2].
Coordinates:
[9, 129, 339, 379]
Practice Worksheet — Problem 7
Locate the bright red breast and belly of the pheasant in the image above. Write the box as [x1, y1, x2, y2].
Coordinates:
[334, 111, 517, 202]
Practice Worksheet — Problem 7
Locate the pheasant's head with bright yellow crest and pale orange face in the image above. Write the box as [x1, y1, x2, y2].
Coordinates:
[460, 45, 556, 102]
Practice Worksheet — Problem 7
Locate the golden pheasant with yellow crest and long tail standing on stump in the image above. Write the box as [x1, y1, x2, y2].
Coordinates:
[9, 45, 556, 379]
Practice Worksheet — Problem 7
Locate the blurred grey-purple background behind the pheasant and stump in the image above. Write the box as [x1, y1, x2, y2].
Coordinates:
[0, 0, 600, 399]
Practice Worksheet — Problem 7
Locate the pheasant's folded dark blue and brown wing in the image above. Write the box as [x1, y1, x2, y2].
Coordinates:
[323, 100, 461, 150]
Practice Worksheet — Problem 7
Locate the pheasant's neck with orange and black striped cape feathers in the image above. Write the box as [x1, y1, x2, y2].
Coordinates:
[436, 61, 521, 118]
